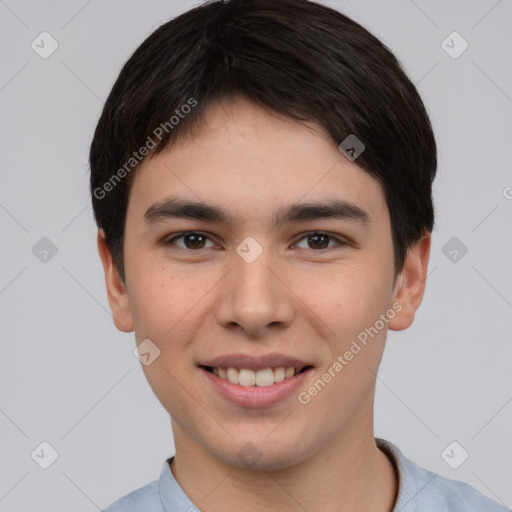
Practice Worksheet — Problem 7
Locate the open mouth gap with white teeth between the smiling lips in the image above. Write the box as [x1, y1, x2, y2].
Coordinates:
[200, 365, 313, 387]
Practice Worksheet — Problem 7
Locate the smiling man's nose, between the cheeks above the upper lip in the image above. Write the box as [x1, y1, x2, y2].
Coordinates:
[215, 242, 295, 337]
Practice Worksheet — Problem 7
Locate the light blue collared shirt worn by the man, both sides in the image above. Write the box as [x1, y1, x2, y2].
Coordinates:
[103, 439, 510, 512]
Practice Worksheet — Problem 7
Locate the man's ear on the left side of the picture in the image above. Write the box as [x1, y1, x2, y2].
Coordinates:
[98, 229, 133, 332]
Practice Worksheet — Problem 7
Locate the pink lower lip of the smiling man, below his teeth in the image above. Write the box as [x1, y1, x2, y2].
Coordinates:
[200, 368, 313, 408]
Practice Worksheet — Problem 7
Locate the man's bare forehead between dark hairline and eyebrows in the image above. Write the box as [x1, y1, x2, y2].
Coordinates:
[130, 97, 387, 230]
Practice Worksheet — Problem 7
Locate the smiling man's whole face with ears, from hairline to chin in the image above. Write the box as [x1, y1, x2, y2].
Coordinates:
[99, 94, 429, 468]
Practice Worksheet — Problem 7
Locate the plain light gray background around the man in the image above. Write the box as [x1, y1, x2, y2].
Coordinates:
[0, 0, 512, 512]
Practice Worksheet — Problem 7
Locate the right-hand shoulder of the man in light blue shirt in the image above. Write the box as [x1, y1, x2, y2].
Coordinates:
[377, 439, 510, 512]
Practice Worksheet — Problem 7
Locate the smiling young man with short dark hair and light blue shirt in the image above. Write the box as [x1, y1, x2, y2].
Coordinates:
[90, 0, 505, 512]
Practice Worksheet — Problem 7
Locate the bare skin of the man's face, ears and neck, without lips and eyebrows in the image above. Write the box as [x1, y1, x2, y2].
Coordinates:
[98, 97, 430, 512]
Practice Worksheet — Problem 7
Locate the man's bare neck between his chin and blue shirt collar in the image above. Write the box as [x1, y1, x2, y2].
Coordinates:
[171, 414, 398, 512]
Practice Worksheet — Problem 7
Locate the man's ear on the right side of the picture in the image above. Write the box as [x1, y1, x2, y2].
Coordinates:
[388, 232, 431, 331]
